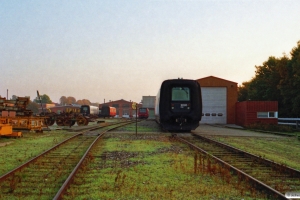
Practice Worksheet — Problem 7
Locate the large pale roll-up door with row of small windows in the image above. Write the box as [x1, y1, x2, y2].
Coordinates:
[200, 87, 227, 124]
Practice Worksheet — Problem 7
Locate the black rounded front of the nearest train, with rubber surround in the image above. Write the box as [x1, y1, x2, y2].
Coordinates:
[159, 79, 202, 131]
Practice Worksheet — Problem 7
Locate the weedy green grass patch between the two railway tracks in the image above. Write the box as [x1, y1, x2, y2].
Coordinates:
[64, 134, 266, 199]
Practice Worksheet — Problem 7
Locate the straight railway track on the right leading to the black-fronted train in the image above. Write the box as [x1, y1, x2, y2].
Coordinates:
[175, 134, 300, 199]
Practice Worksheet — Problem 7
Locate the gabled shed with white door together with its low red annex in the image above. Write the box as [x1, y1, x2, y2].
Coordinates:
[196, 76, 278, 126]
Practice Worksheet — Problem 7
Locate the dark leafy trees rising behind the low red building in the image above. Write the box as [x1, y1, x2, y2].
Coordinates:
[238, 41, 300, 117]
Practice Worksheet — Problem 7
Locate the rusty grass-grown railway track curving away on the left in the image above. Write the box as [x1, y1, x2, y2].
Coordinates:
[0, 119, 133, 199]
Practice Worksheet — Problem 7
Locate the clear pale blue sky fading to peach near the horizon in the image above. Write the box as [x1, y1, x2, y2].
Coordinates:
[0, 0, 300, 103]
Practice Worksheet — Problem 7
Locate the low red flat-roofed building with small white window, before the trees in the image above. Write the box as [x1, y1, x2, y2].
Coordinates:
[236, 101, 278, 126]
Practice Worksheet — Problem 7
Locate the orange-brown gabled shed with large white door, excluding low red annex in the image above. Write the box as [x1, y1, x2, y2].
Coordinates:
[196, 76, 238, 124]
